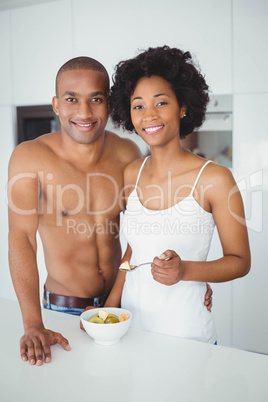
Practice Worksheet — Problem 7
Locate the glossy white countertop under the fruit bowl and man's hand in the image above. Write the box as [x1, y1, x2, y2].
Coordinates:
[0, 299, 268, 402]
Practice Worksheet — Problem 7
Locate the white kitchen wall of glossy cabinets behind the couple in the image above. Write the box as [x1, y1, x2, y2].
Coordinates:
[0, 0, 268, 353]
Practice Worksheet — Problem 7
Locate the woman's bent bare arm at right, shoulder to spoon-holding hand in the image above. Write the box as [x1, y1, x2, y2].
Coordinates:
[152, 165, 250, 285]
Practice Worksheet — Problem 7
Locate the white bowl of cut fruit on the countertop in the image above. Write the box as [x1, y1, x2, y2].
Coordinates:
[80, 307, 132, 345]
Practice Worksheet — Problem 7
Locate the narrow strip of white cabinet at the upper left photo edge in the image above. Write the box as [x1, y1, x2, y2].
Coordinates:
[0, 11, 12, 105]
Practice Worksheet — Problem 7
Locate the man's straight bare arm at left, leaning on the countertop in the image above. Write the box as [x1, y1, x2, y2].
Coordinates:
[8, 144, 70, 365]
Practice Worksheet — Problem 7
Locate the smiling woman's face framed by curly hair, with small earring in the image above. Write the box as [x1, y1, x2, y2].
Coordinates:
[130, 75, 186, 146]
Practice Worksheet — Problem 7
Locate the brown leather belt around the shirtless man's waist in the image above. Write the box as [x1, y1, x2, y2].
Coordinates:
[44, 286, 108, 309]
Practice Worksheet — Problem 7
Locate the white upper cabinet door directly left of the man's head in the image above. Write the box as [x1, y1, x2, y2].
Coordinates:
[11, 0, 73, 106]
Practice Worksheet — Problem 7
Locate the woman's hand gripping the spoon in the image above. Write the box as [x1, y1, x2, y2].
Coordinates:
[152, 250, 185, 286]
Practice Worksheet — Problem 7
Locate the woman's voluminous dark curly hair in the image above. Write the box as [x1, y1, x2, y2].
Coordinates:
[109, 46, 209, 138]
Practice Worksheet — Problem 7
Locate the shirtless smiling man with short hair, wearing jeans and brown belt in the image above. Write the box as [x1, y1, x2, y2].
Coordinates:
[8, 57, 210, 365]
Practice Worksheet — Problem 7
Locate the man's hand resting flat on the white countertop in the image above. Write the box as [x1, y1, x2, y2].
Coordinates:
[20, 327, 71, 366]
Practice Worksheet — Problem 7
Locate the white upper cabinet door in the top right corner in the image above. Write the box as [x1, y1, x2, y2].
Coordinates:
[233, 0, 268, 93]
